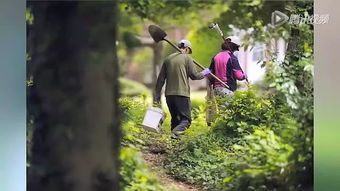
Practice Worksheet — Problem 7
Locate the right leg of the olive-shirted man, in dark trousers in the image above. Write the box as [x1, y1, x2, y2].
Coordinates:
[172, 96, 191, 135]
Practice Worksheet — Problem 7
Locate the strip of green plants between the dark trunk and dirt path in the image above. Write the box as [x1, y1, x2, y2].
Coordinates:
[120, 96, 174, 191]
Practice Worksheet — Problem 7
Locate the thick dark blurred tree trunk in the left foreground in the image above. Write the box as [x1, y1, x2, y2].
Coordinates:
[28, 1, 120, 191]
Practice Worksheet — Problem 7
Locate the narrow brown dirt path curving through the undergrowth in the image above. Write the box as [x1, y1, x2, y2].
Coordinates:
[143, 151, 198, 191]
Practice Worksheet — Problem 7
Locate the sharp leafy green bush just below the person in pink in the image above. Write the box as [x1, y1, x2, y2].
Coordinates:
[215, 90, 296, 138]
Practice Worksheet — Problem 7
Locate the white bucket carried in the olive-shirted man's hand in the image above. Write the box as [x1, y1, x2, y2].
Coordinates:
[142, 107, 165, 132]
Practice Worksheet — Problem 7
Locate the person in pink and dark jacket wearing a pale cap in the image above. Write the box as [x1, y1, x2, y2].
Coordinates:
[209, 36, 247, 96]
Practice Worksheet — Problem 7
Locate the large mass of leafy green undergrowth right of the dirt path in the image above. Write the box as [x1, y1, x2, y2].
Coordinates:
[165, 90, 296, 190]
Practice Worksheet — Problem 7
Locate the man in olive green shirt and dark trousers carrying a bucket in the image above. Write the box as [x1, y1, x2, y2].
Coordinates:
[154, 40, 210, 136]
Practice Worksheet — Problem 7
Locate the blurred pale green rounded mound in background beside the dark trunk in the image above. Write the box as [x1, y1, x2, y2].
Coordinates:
[119, 78, 149, 96]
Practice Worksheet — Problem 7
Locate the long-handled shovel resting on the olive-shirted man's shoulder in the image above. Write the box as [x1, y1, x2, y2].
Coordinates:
[149, 25, 229, 89]
